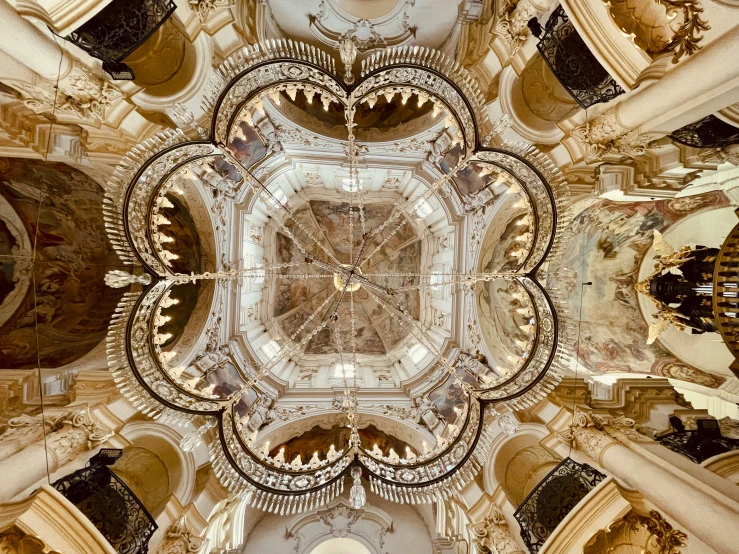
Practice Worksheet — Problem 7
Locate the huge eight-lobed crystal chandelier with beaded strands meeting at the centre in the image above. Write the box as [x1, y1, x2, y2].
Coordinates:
[104, 41, 572, 514]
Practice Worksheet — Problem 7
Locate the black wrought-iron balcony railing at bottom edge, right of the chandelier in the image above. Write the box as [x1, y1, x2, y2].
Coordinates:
[513, 458, 606, 554]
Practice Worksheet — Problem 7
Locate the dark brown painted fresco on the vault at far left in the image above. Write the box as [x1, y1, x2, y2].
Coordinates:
[0, 159, 122, 369]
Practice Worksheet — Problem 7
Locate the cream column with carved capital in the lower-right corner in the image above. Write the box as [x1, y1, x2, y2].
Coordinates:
[560, 412, 739, 552]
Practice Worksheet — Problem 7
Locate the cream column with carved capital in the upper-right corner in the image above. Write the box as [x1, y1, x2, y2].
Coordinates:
[569, 25, 739, 161]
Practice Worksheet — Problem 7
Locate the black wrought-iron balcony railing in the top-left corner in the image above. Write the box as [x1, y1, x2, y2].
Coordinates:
[64, 0, 177, 80]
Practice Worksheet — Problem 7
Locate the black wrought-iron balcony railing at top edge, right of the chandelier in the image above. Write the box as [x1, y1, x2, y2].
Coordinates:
[537, 5, 624, 108]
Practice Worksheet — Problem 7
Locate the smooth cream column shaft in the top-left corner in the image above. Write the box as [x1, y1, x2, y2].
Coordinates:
[0, 0, 72, 80]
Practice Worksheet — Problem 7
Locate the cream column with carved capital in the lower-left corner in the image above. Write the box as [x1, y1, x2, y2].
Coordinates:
[0, 410, 112, 502]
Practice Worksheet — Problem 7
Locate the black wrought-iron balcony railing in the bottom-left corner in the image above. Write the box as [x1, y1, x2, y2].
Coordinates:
[52, 449, 157, 554]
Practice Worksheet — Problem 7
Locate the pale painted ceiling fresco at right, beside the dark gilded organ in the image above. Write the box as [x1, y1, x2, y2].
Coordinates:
[550, 192, 729, 387]
